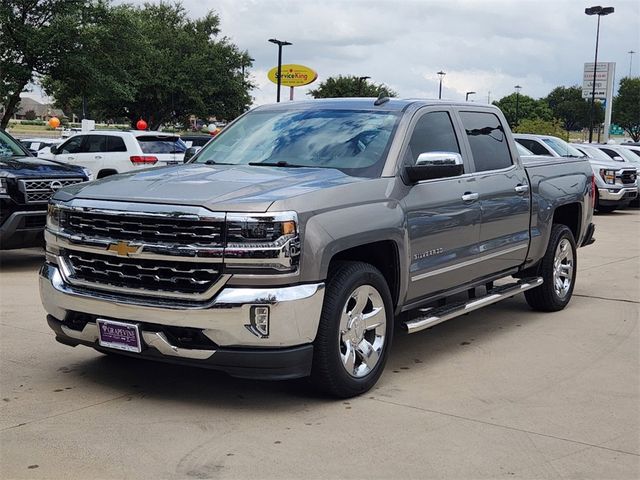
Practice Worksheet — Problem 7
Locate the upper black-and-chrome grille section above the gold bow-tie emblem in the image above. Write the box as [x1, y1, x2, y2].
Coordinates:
[60, 210, 224, 247]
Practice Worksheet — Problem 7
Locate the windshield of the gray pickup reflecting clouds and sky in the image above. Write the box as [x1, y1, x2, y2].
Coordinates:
[194, 109, 400, 178]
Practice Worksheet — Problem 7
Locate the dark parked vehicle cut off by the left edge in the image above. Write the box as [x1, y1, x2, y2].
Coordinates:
[0, 130, 88, 250]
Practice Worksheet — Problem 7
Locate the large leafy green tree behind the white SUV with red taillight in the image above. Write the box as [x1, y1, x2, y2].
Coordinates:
[43, 3, 252, 129]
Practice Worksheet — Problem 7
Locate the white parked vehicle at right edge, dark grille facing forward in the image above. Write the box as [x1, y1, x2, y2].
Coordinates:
[572, 143, 638, 213]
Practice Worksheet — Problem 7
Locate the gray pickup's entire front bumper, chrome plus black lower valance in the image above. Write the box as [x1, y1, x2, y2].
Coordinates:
[40, 263, 324, 378]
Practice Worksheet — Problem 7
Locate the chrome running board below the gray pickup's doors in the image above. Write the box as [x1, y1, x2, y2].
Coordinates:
[403, 277, 543, 333]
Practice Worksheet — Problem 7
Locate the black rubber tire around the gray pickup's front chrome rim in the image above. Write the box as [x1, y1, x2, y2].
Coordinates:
[310, 262, 393, 398]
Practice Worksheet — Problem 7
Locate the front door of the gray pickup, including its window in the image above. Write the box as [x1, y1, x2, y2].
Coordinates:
[403, 107, 481, 301]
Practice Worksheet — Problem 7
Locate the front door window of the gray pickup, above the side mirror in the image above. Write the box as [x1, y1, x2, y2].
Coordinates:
[407, 112, 460, 165]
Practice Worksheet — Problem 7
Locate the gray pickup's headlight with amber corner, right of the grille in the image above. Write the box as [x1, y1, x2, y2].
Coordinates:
[224, 212, 300, 273]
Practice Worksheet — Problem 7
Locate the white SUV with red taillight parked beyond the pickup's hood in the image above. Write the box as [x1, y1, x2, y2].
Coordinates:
[41, 130, 187, 178]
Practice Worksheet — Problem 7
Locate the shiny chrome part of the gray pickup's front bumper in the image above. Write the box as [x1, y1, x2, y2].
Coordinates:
[40, 263, 324, 348]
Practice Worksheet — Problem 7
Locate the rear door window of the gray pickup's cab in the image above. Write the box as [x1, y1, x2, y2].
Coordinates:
[460, 112, 512, 172]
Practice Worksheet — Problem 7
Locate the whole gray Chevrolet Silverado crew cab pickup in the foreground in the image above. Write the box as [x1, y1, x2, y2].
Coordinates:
[40, 98, 594, 397]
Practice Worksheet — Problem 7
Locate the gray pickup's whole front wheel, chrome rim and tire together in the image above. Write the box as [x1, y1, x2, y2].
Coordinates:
[311, 262, 393, 398]
